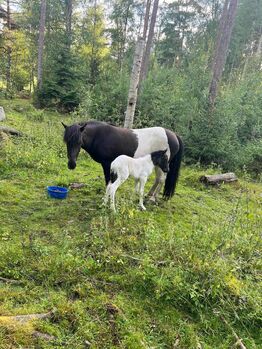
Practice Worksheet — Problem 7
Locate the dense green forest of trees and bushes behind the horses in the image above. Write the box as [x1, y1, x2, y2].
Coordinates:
[0, 0, 262, 176]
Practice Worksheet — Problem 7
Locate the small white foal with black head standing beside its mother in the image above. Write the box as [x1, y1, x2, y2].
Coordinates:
[104, 149, 169, 212]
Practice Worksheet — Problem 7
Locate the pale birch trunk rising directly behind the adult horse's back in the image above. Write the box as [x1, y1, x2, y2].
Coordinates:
[124, 38, 145, 128]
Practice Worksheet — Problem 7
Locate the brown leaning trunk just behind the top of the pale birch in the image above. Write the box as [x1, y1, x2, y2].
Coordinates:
[139, 0, 159, 84]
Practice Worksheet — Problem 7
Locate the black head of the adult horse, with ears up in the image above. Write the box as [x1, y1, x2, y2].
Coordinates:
[62, 122, 86, 170]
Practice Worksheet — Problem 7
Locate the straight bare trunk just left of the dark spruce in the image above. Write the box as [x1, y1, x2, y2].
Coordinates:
[37, 0, 46, 89]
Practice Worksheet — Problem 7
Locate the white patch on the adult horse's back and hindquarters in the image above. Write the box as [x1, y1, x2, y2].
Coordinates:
[132, 127, 170, 159]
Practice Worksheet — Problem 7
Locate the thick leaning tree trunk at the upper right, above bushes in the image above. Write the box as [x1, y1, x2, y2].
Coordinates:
[209, 0, 238, 112]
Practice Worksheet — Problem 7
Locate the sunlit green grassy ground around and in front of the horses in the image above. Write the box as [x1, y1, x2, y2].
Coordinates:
[0, 100, 262, 349]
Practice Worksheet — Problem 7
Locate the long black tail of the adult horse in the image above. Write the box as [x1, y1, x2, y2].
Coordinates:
[163, 136, 184, 200]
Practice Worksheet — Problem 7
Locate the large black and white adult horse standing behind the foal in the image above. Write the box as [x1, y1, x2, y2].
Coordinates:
[63, 121, 183, 199]
